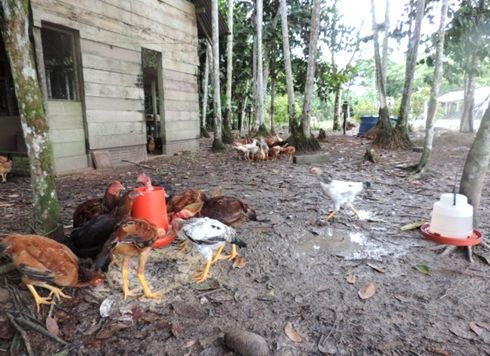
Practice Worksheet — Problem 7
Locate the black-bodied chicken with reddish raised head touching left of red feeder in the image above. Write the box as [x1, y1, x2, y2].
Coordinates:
[70, 190, 143, 259]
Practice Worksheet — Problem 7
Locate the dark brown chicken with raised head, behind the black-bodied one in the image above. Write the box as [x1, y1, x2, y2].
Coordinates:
[73, 180, 125, 228]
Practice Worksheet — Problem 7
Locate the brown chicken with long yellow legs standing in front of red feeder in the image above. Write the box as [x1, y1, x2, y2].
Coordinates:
[95, 219, 165, 299]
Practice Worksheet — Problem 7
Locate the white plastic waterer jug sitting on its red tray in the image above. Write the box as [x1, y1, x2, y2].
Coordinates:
[429, 193, 473, 239]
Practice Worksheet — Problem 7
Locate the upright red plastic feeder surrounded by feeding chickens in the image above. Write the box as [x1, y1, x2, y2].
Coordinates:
[131, 187, 175, 248]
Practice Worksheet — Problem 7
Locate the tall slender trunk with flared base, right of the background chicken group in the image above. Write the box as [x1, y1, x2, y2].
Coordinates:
[301, 0, 320, 137]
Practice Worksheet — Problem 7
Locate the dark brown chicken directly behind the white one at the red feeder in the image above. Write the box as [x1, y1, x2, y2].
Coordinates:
[176, 195, 257, 260]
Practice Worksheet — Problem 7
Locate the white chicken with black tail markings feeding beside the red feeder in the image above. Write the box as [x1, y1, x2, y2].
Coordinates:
[172, 217, 247, 283]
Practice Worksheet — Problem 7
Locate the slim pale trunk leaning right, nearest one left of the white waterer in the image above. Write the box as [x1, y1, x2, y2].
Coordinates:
[417, 0, 449, 175]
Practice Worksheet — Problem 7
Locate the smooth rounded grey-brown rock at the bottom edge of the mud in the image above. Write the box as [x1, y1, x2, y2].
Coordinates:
[225, 329, 269, 356]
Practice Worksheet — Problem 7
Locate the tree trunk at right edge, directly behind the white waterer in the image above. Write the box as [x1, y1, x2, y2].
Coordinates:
[459, 104, 490, 228]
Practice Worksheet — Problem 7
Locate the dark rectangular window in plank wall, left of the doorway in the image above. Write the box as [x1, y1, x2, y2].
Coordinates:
[41, 26, 79, 100]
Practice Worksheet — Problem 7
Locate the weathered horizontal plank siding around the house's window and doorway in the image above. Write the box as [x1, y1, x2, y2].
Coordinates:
[31, 0, 199, 168]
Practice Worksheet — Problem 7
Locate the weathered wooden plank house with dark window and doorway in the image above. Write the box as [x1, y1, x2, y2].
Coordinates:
[0, 0, 226, 173]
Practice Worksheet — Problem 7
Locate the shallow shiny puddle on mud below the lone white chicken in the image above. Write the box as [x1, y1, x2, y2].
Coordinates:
[298, 228, 407, 260]
